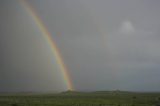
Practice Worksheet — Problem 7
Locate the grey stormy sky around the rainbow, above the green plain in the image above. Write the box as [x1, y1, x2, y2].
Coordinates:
[0, 0, 160, 92]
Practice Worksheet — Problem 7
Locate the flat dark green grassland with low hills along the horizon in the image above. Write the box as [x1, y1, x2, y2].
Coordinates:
[0, 91, 160, 106]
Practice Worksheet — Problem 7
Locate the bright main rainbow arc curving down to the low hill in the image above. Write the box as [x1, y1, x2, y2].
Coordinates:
[19, 0, 74, 90]
